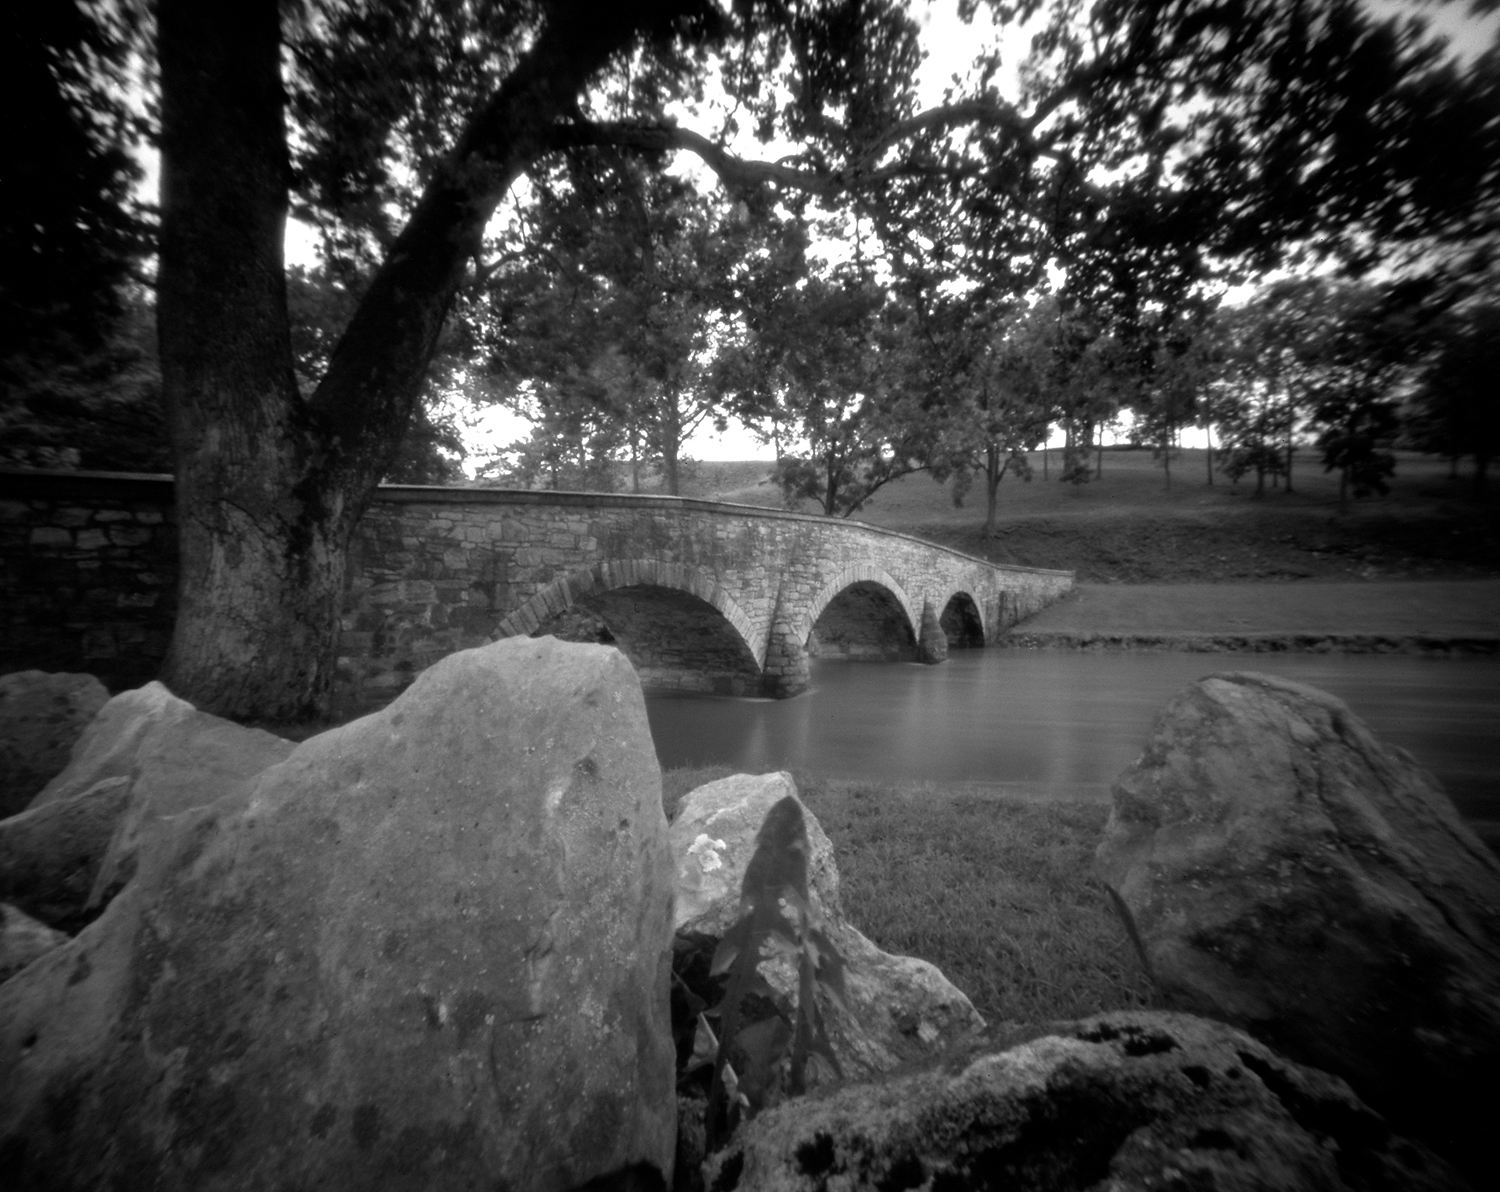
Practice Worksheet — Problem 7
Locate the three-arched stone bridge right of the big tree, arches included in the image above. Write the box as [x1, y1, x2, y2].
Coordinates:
[341, 486, 1073, 703]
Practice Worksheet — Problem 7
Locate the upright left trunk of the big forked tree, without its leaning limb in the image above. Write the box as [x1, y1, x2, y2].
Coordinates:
[158, 0, 350, 720]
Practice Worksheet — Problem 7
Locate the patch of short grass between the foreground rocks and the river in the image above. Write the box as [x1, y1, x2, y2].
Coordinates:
[663, 766, 1151, 1023]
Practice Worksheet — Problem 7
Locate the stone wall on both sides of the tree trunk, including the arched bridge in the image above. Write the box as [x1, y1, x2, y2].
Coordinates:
[0, 472, 1073, 711]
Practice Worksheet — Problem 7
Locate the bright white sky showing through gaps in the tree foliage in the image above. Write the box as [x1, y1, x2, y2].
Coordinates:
[276, 0, 1500, 474]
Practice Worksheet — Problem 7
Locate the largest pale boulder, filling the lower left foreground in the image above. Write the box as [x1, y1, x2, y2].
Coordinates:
[0, 639, 674, 1192]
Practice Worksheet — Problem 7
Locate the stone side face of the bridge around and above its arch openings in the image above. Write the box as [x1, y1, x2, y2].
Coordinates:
[344, 486, 1073, 697]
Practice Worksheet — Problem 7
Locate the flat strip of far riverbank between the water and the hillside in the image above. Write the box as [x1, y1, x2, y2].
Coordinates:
[1011, 580, 1500, 652]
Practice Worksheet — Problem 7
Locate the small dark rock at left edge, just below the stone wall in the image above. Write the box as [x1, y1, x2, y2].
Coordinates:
[0, 670, 110, 819]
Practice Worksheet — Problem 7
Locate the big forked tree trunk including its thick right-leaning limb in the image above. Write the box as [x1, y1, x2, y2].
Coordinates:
[158, 0, 663, 720]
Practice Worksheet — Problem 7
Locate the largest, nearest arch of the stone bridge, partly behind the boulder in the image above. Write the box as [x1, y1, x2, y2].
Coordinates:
[495, 559, 765, 694]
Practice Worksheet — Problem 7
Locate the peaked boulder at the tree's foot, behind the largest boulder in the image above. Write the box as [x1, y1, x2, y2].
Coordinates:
[0, 682, 293, 931]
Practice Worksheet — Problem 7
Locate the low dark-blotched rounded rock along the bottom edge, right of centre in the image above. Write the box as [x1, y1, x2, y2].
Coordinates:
[704, 1012, 1466, 1192]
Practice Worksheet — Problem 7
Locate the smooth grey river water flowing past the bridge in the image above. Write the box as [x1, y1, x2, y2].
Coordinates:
[647, 649, 1500, 820]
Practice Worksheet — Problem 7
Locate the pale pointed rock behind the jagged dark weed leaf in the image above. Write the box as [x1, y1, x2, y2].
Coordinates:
[672, 774, 984, 1080]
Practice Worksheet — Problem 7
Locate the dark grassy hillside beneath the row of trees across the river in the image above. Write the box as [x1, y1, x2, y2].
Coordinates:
[684, 448, 1500, 583]
